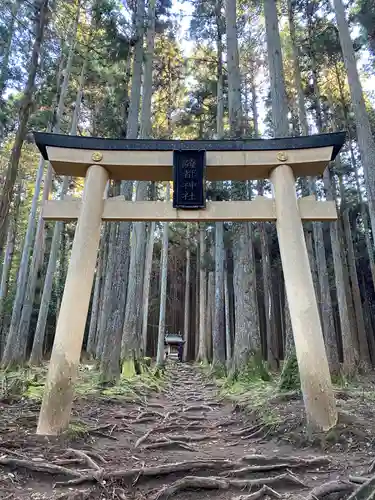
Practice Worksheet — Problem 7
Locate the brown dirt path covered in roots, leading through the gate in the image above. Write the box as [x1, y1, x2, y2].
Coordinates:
[0, 364, 369, 500]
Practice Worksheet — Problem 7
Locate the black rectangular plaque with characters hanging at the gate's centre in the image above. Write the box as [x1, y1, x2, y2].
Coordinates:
[173, 150, 206, 209]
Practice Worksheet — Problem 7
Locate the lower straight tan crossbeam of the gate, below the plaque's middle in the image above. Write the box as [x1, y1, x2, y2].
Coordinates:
[42, 196, 337, 222]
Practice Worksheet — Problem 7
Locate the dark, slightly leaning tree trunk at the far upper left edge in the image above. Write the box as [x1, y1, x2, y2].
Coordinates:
[0, 0, 48, 255]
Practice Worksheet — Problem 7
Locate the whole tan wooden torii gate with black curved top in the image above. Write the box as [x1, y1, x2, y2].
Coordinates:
[34, 132, 345, 435]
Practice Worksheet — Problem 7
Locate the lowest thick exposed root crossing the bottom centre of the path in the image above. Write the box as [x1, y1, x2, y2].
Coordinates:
[152, 474, 305, 500]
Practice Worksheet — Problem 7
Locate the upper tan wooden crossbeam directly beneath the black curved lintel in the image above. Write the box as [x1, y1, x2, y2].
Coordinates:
[41, 146, 333, 181]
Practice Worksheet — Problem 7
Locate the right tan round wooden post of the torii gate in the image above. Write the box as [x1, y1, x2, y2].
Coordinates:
[271, 165, 337, 430]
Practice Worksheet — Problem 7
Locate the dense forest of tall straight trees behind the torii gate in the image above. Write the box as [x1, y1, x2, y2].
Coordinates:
[0, 0, 375, 386]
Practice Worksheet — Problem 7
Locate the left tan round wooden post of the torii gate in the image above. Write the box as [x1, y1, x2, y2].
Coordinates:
[37, 165, 108, 435]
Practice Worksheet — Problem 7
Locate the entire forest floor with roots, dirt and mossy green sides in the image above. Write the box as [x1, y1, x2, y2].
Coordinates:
[0, 363, 375, 500]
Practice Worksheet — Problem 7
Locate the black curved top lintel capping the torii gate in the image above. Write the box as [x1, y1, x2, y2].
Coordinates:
[34, 132, 346, 160]
